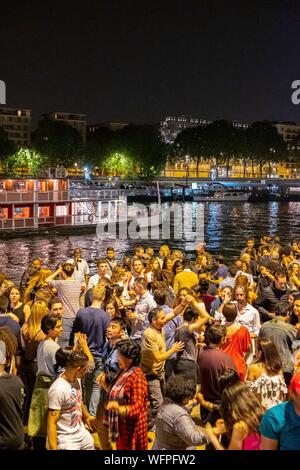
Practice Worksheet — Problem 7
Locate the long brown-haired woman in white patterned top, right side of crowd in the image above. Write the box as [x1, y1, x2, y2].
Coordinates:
[246, 337, 287, 410]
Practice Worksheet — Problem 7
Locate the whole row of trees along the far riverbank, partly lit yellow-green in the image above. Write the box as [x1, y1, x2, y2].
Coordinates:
[0, 118, 299, 178]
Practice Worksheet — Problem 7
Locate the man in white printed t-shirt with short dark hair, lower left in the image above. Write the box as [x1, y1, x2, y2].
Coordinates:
[47, 351, 95, 450]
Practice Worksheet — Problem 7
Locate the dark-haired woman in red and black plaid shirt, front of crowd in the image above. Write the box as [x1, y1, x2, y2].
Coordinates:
[104, 339, 148, 450]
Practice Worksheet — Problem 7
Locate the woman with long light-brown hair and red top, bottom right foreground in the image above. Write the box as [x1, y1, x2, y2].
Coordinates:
[205, 382, 264, 450]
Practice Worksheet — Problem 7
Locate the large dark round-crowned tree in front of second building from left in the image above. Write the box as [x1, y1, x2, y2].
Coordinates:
[33, 118, 83, 167]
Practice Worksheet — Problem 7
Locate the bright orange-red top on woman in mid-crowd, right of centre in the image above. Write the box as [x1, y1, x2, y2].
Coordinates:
[221, 326, 251, 381]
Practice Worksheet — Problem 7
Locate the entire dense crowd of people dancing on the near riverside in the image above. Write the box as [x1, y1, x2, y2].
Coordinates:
[0, 236, 300, 450]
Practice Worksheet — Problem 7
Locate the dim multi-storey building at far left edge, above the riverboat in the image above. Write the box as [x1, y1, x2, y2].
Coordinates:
[0, 106, 31, 147]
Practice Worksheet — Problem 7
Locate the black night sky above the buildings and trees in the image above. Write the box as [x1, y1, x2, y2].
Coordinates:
[0, 0, 300, 123]
